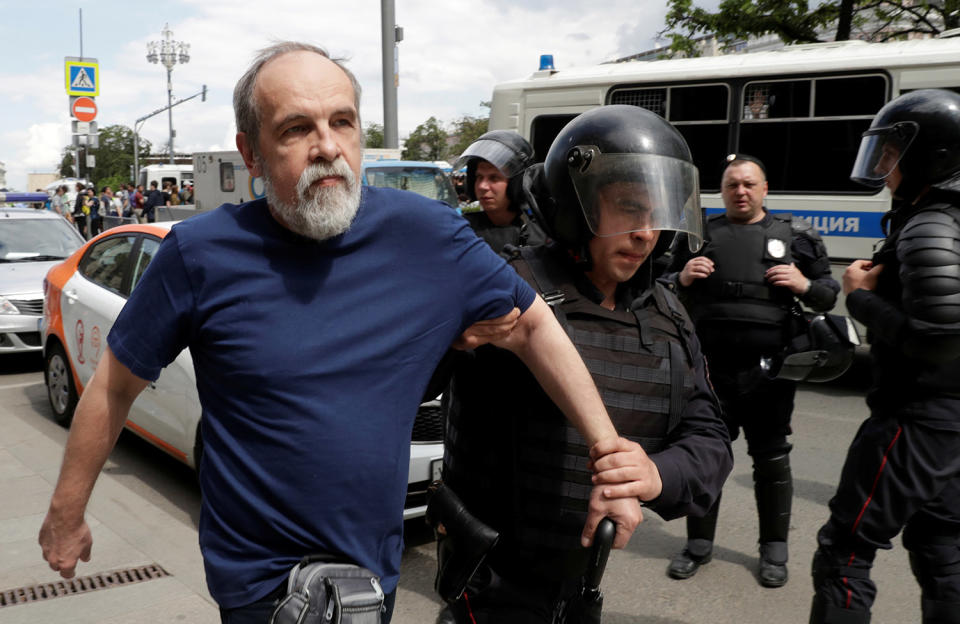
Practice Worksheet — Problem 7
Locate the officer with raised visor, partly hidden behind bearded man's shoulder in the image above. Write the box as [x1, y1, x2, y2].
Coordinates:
[453, 130, 546, 253]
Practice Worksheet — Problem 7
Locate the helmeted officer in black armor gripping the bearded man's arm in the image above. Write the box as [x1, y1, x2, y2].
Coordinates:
[441, 106, 732, 624]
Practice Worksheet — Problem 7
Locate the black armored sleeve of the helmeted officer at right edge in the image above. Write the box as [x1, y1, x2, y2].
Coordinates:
[847, 210, 960, 363]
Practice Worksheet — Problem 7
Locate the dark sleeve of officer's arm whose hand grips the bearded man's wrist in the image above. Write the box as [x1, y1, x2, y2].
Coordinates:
[646, 314, 733, 520]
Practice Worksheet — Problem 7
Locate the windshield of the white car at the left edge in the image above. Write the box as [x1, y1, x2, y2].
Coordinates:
[0, 219, 83, 262]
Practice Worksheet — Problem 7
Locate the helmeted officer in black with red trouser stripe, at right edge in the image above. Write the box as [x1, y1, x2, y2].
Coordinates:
[810, 89, 960, 624]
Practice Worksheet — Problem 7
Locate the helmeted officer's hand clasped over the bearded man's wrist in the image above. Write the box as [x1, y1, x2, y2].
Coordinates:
[590, 438, 663, 501]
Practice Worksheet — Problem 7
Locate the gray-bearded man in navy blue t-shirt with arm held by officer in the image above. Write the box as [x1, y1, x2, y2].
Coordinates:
[40, 43, 642, 622]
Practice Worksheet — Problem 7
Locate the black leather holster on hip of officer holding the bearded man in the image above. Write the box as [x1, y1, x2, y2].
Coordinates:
[426, 481, 500, 604]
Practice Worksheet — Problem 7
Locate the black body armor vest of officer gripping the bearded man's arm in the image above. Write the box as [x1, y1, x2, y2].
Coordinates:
[444, 247, 694, 578]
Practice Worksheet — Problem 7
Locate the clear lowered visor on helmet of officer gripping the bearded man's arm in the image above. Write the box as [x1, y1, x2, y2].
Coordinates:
[567, 146, 703, 251]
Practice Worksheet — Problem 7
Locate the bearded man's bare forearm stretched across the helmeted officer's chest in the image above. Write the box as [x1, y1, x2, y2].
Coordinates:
[495, 297, 617, 446]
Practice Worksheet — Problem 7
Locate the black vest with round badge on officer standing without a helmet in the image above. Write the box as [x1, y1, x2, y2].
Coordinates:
[689, 215, 793, 327]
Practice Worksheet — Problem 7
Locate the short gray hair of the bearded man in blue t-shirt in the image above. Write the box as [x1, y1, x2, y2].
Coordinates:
[233, 41, 366, 153]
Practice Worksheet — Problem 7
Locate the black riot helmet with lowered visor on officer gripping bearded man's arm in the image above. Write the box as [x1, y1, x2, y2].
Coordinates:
[540, 105, 703, 256]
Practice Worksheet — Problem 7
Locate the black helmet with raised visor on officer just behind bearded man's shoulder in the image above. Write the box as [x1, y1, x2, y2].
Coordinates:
[453, 130, 533, 205]
